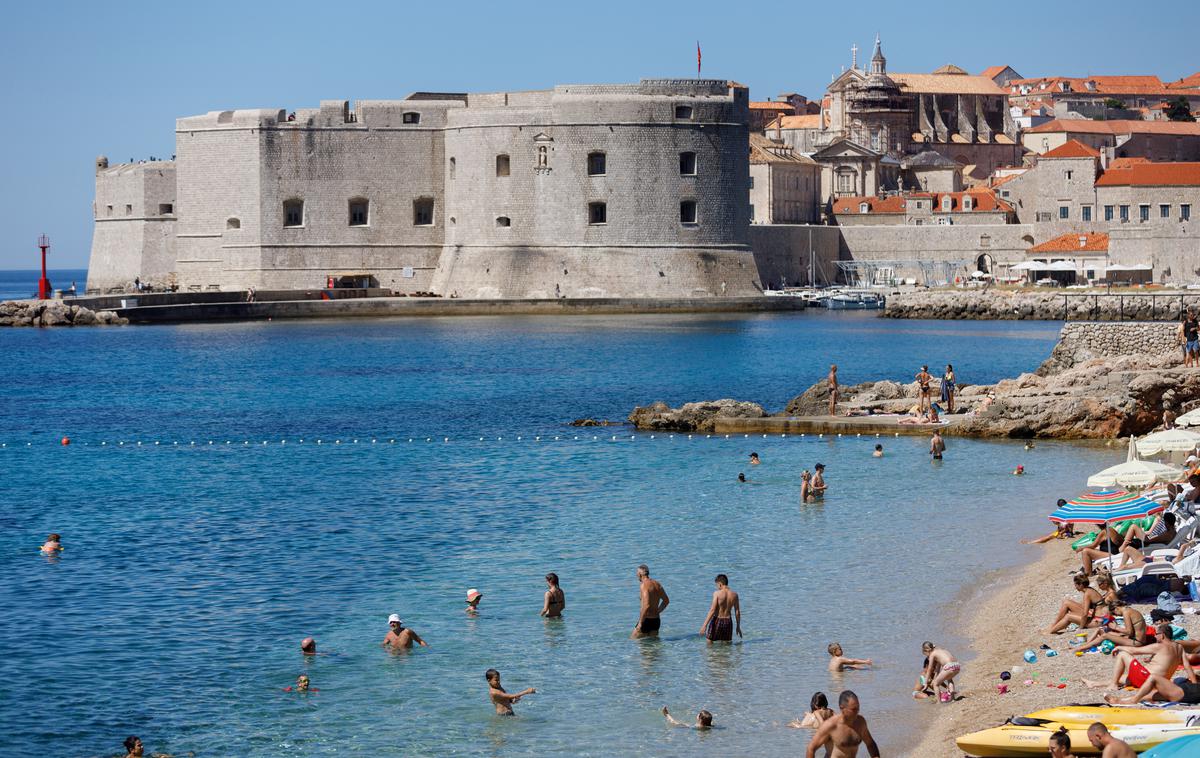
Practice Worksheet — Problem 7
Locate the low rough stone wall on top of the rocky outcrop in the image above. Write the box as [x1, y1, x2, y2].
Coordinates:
[1038, 321, 1180, 375]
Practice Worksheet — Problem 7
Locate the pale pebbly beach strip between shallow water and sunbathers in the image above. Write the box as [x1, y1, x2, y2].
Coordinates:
[910, 541, 1200, 758]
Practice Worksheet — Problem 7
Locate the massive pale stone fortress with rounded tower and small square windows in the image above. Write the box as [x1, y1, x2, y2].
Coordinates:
[88, 79, 761, 299]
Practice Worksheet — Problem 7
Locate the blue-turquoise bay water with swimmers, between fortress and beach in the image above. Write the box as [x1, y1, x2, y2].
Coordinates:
[0, 314, 1118, 756]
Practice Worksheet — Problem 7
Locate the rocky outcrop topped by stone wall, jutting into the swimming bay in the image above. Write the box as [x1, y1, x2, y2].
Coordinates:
[629, 323, 1200, 439]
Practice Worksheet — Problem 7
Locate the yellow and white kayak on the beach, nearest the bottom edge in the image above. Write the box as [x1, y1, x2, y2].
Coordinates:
[956, 721, 1200, 758]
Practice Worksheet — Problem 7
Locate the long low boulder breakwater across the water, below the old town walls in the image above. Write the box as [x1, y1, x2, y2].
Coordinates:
[882, 289, 1200, 321]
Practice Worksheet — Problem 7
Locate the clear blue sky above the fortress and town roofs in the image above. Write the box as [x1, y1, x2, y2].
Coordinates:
[0, 0, 1200, 269]
